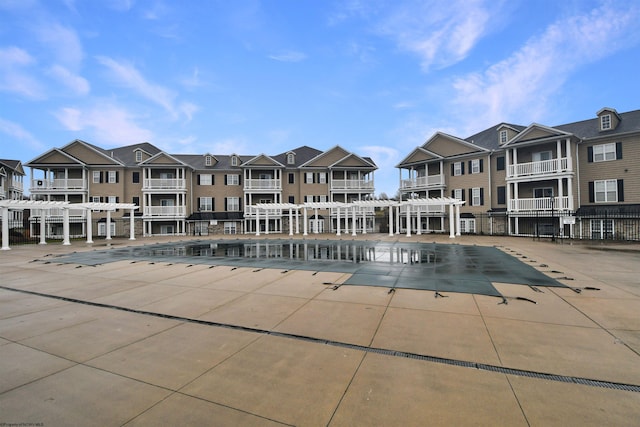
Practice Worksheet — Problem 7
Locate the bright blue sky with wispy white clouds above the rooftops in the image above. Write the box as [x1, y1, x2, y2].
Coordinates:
[0, 0, 640, 196]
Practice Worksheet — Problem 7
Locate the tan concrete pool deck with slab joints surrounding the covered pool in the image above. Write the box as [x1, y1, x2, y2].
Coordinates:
[0, 234, 640, 427]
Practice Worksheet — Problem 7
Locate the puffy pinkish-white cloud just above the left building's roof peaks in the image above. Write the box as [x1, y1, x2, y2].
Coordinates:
[54, 102, 153, 147]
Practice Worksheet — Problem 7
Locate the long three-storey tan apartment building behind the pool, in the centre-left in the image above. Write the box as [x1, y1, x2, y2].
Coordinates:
[26, 140, 376, 237]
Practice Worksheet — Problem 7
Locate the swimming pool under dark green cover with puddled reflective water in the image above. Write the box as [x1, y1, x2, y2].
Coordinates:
[56, 239, 567, 296]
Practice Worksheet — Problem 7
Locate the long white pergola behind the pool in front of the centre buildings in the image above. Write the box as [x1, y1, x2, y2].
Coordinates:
[253, 197, 465, 238]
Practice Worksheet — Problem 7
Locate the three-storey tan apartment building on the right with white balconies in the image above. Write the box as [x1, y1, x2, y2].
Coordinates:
[396, 108, 640, 239]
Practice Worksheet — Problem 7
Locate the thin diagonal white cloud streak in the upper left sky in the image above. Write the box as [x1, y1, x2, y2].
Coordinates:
[96, 56, 177, 117]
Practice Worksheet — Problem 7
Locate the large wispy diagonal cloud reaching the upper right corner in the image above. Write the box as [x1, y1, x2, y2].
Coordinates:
[452, 3, 640, 131]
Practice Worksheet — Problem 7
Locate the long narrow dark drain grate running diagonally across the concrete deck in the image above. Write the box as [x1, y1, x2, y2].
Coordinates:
[0, 285, 640, 393]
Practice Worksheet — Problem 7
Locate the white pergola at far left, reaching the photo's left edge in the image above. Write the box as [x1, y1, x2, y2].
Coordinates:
[0, 200, 138, 250]
